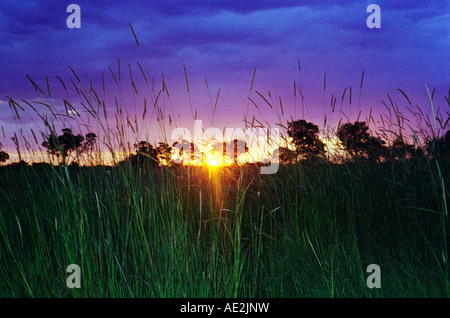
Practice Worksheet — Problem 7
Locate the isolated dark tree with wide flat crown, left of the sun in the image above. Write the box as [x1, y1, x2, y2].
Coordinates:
[42, 128, 97, 164]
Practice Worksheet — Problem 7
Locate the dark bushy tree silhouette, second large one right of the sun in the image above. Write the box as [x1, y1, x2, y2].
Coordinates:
[337, 121, 386, 160]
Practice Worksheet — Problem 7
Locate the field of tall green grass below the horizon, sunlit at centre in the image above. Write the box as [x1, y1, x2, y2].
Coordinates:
[0, 155, 450, 297]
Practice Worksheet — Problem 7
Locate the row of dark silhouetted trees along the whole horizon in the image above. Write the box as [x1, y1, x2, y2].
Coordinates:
[0, 119, 450, 166]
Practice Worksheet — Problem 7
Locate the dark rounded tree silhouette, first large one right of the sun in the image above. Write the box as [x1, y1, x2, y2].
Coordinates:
[287, 119, 325, 160]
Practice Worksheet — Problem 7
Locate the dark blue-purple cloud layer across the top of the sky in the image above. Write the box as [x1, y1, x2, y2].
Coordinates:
[0, 0, 450, 120]
